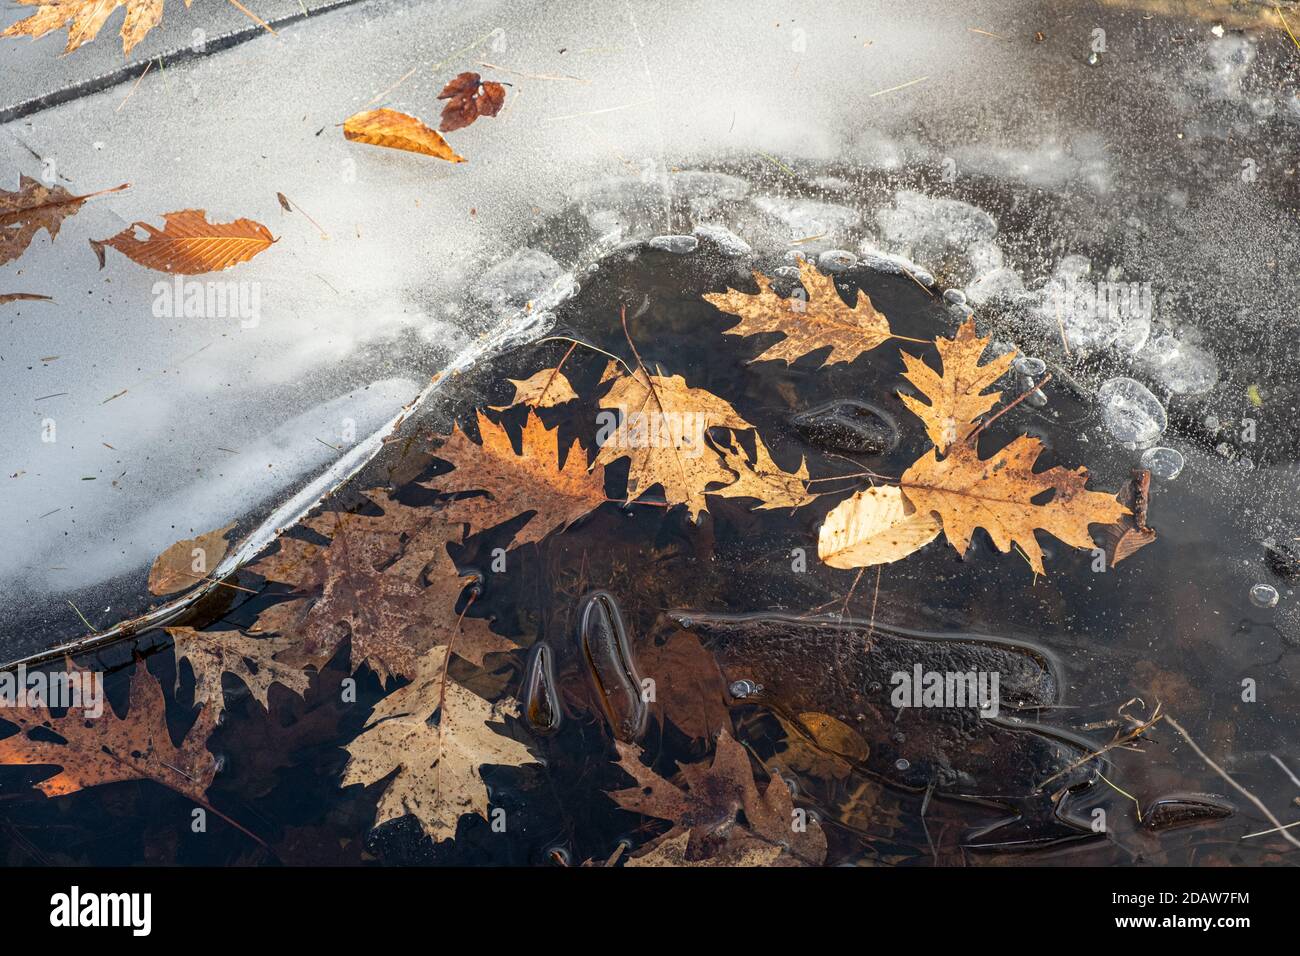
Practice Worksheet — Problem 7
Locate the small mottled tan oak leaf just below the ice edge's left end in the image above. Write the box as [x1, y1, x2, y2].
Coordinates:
[165, 627, 309, 713]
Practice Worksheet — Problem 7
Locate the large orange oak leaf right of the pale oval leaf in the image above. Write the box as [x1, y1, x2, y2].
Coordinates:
[900, 434, 1128, 574]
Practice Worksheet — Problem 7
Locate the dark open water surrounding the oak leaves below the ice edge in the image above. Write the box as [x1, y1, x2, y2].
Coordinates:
[0, 214, 1300, 865]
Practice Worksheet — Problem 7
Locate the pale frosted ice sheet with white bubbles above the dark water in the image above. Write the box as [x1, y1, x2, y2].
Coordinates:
[0, 1, 1300, 657]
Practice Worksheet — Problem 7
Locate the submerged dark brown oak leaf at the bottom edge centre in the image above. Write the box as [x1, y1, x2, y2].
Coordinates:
[610, 730, 826, 865]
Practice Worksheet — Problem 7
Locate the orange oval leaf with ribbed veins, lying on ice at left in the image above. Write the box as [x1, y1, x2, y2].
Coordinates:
[90, 209, 277, 276]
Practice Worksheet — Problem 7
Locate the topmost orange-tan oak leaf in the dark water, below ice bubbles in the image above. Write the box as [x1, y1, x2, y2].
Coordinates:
[705, 259, 891, 365]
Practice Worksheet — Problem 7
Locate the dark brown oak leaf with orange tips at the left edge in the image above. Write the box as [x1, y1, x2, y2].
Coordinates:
[0, 662, 217, 803]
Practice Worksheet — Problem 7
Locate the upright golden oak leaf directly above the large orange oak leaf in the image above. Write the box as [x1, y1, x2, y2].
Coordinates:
[898, 316, 1015, 451]
